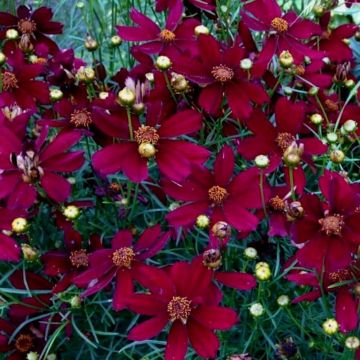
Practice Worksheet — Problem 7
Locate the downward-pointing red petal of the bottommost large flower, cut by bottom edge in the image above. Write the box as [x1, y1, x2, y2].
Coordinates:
[165, 321, 188, 360]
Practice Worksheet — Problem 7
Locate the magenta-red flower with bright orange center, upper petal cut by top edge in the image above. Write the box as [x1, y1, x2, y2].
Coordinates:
[241, 0, 324, 64]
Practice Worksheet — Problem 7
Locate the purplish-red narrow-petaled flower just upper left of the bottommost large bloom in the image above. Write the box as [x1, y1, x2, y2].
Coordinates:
[73, 225, 170, 311]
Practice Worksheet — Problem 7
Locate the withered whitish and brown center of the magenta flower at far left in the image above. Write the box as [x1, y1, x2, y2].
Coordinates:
[10, 150, 44, 183]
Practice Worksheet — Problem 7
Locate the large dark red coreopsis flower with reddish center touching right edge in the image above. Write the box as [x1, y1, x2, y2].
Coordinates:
[290, 171, 360, 273]
